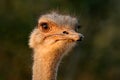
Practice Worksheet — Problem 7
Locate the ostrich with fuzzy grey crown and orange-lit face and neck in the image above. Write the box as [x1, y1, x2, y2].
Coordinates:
[29, 12, 83, 80]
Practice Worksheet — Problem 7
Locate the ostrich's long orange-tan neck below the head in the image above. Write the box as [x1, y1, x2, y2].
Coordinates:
[32, 48, 64, 80]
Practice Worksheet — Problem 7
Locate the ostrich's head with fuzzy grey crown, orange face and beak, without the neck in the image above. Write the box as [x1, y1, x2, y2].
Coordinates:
[29, 12, 83, 53]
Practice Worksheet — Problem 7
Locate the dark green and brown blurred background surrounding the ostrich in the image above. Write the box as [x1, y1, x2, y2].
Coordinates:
[0, 0, 120, 80]
